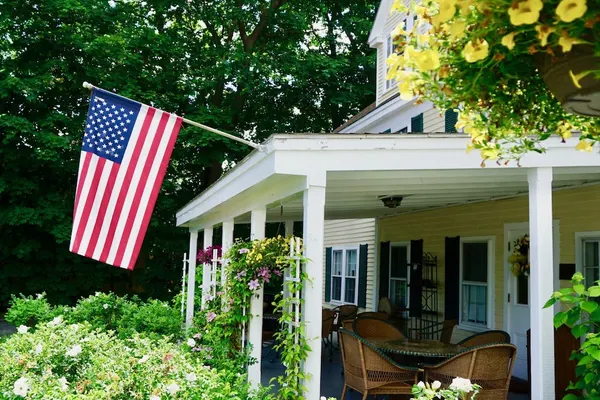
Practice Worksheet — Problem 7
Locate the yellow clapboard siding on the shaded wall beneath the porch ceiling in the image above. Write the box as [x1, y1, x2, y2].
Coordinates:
[379, 186, 600, 340]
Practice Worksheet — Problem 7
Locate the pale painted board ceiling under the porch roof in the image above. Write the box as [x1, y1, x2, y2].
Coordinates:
[264, 167, 600, 222]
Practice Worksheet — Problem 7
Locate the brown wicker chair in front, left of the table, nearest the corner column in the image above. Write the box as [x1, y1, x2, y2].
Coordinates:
[339, 328, 422, 400]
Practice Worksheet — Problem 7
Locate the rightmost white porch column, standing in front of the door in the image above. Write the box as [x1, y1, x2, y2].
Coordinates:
[527, 168, 555, 399]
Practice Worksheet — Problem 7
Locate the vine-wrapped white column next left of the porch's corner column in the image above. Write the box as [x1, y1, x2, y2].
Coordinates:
[248, 208, 267, 388]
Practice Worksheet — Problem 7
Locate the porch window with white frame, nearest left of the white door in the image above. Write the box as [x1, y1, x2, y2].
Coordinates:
[460, 238, 493, 328]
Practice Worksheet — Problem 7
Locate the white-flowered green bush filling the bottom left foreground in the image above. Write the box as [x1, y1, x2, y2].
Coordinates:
[0, 317, 269, 400]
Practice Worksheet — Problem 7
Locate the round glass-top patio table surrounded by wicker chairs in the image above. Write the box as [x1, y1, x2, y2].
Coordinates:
[368, 338, 465, 358]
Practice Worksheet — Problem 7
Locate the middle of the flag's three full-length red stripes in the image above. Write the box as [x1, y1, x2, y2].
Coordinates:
[114, 113, 170, 266]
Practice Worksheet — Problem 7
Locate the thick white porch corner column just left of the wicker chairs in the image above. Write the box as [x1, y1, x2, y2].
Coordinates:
[302, 183, 325, 399]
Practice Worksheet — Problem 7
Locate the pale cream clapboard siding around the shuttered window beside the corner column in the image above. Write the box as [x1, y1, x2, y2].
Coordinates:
[323, 218, 375, 310]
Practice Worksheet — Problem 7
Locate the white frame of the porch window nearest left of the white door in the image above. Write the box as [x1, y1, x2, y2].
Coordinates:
[458, 236, 496, 332]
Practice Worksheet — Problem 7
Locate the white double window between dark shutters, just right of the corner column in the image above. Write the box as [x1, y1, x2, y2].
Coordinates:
[331, 247, 358, 304]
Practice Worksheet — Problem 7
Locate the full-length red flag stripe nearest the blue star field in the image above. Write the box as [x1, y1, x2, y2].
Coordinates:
[99, 107, 156, 263]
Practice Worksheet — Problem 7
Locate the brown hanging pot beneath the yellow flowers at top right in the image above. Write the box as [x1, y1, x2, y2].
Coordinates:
[538, 45, 600, 117]
